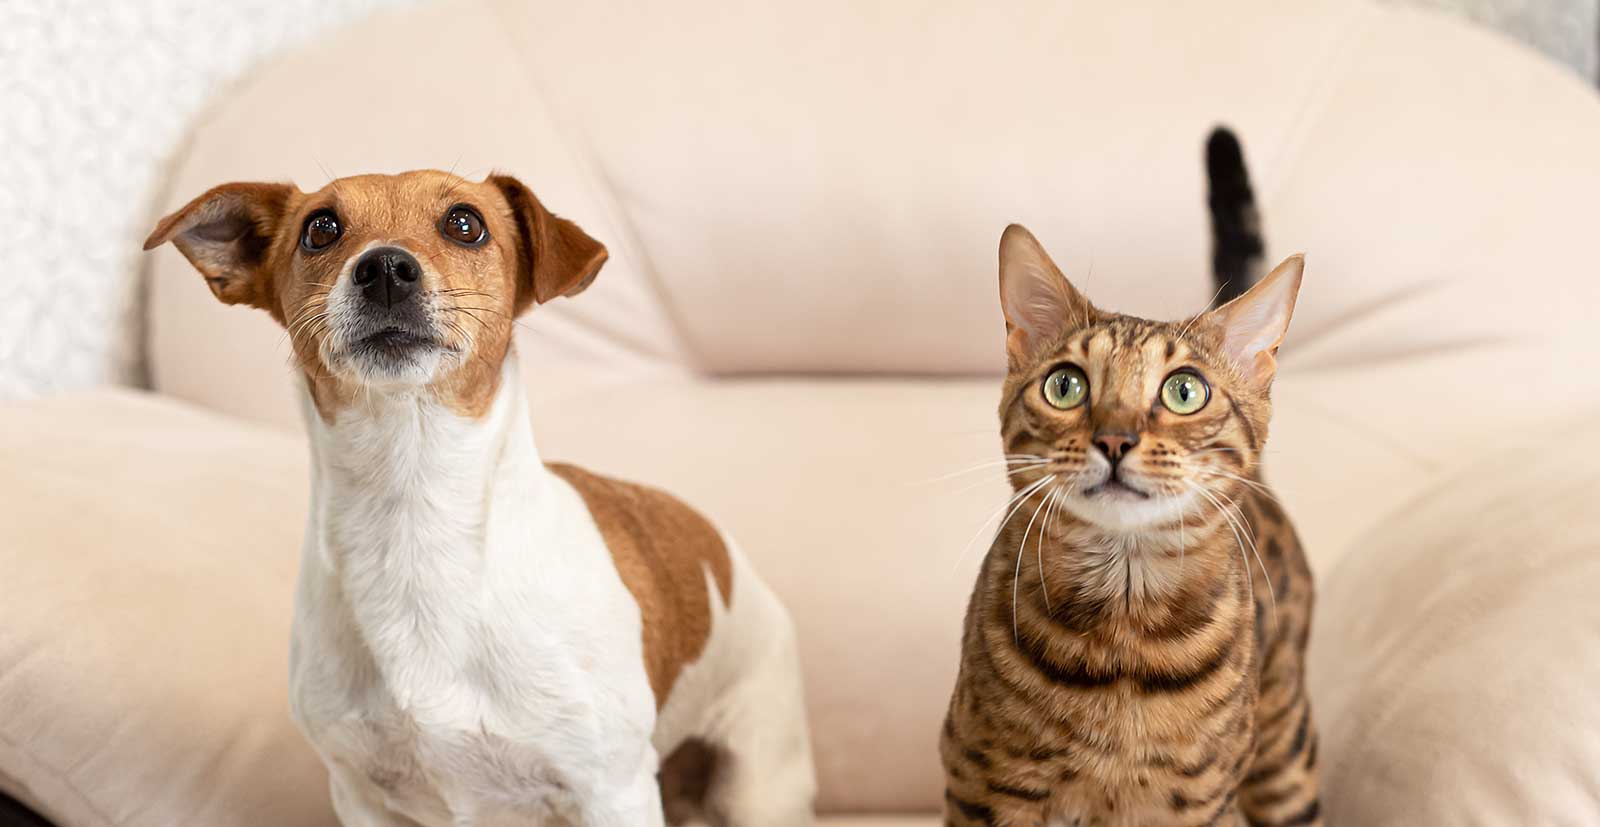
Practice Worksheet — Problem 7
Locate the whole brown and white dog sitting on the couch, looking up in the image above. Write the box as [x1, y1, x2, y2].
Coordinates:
[146, 171, 814, 827]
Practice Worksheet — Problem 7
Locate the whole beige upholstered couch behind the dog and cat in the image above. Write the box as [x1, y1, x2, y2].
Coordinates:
[0, 0, 1600, 827]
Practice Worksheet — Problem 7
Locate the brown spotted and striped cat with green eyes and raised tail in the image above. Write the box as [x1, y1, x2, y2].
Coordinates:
[941, 131, 1322, 827]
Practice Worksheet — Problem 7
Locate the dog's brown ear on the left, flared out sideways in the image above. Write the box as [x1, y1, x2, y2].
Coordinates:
[144, 184, 298, 309]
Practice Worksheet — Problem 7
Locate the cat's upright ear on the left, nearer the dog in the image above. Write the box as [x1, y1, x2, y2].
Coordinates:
[1000, 224, 1096, 365]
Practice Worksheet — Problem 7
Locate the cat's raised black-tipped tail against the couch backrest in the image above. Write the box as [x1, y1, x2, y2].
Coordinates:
[1205, 126, 1266, 307]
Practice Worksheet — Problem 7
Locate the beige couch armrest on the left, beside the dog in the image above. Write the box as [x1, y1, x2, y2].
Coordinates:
[0, 392, 336, 827]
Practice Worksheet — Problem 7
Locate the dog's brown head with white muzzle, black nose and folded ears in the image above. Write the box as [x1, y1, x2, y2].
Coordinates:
[144, 170, 606, 417]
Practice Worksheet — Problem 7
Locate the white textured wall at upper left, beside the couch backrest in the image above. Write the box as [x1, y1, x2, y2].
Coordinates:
[0, 0, 413, 398]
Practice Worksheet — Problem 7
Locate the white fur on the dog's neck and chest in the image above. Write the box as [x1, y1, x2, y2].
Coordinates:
[291, 375, 656, 827]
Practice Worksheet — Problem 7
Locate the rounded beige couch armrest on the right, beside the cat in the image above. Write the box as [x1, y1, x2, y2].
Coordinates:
[1310, 411, 1600, 827]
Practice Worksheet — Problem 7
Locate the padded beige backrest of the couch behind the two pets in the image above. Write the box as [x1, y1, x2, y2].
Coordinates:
[152, 0, 1600, 435]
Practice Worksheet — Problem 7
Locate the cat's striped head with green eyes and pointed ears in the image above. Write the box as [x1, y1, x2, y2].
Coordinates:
[1000, 224, 1304, 533]
